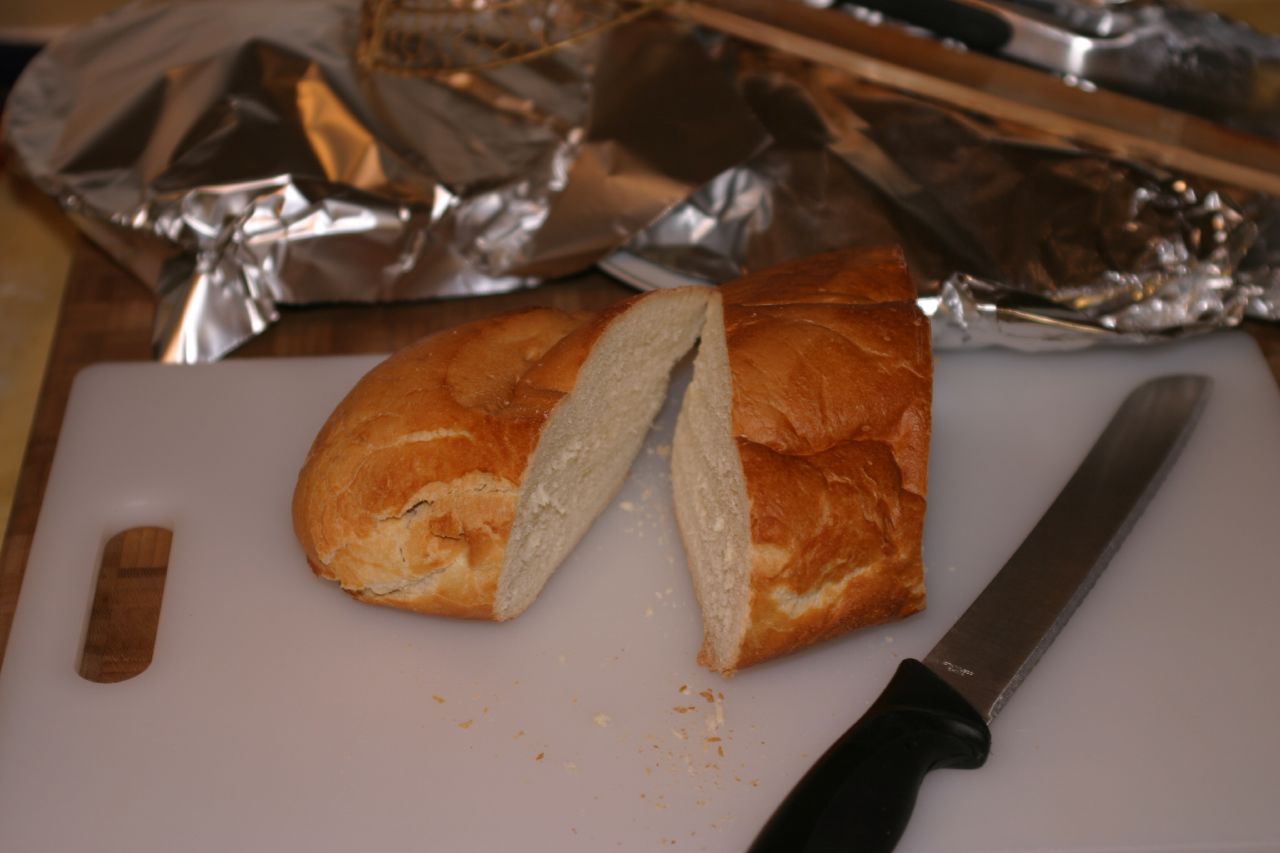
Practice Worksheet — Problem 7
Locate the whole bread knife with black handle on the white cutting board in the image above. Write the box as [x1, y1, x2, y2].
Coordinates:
[750, 374, 1212, 853]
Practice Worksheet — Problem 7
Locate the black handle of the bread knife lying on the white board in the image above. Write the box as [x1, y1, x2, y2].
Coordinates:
[750, 660, 991, 853]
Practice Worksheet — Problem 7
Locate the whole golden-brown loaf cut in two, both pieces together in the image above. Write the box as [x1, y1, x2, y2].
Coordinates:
[293, 242, 932, 672]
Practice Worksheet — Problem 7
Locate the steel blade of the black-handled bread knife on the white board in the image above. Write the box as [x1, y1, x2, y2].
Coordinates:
[924, 375, 1211, 722]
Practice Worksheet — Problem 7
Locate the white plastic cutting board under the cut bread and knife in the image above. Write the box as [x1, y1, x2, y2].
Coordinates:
[0, 334, 1280, 853]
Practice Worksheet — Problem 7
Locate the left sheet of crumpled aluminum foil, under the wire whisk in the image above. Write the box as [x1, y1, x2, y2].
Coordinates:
[5, 0, 767, 362]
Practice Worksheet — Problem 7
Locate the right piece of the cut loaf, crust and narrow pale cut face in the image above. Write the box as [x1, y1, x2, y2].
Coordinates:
[672, 250, 933, 672]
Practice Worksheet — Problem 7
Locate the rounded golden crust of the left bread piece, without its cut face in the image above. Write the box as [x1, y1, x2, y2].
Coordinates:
[293, 300, 630, 619]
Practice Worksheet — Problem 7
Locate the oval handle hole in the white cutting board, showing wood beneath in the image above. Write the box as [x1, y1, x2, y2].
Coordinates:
[78, 528, 173, 684]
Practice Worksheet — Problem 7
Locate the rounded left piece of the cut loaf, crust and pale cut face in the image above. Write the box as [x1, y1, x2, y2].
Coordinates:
[293, 287, 712, 620]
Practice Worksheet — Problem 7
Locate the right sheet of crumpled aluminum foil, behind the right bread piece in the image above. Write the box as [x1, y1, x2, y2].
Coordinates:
[620, 40, 1280, 350]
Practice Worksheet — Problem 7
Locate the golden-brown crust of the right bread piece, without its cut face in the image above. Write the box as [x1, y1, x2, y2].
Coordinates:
[722, 250, 933, 669]
